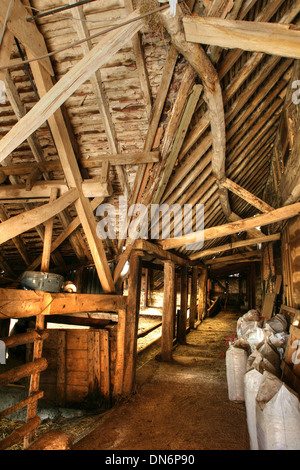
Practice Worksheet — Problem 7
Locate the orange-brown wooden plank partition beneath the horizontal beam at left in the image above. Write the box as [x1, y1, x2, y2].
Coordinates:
[41, 328, 116, 406]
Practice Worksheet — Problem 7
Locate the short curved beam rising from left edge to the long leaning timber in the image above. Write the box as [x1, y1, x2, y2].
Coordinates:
[0, 189, 78, 244]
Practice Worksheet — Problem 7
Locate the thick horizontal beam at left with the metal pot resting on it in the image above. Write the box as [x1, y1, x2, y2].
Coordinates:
[0, 288, 127, 319]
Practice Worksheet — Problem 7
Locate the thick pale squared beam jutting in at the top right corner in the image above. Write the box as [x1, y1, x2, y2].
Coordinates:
[183, 16, 300, 59]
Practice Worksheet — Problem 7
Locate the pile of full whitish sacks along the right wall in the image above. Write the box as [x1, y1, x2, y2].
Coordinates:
[226, 310, 300, 450]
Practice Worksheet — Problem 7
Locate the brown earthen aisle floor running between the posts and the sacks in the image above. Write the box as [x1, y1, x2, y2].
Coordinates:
[74, 310, 249, 450]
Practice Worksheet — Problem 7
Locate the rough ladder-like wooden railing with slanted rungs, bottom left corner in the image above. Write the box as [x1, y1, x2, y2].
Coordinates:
[0, 330, 48, 450]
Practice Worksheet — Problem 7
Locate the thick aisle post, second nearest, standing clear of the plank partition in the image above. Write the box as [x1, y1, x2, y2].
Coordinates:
[161, 261, 176, 361]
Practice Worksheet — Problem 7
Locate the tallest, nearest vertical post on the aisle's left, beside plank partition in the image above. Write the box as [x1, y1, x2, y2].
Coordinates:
[123, 251, 142, 396]
